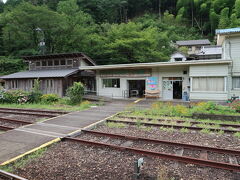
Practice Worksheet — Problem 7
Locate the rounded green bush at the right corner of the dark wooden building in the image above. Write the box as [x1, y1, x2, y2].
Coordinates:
[67, 82, 84, 105]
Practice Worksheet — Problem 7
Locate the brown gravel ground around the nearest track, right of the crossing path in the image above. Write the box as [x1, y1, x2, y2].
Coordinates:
[12, 126, 240, 180]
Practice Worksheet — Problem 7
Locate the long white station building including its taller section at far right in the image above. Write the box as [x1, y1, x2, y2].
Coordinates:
[80, 28, 240, 101]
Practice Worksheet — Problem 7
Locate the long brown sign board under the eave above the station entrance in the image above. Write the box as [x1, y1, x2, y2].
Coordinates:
[100, 69, 152, 77]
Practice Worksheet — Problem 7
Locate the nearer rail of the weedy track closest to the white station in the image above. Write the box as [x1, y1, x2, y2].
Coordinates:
[106, 119, 240, 133]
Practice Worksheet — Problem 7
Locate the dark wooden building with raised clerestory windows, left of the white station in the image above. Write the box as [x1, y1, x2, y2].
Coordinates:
[1, 53, 96, 97]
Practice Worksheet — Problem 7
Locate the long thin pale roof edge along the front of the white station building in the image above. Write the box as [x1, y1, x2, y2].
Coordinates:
[79, 59, 232, 70]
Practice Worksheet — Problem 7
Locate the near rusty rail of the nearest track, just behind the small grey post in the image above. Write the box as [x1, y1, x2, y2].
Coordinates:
[63, 137, 240, 172]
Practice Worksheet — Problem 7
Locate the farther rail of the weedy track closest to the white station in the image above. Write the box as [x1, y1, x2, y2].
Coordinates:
[116, 115, 240, 128]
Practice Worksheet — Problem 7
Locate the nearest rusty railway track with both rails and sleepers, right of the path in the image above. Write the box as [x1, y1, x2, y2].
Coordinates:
[63, 130, 240, 172]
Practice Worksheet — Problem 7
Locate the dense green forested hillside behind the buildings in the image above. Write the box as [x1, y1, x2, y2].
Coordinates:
[0, 0, 240, 69]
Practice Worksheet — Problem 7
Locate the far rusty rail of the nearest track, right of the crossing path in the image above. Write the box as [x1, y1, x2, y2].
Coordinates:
[82, 130, 240, 155]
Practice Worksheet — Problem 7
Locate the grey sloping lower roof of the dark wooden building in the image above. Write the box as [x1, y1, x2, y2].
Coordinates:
[1, 69, 79, 79]
